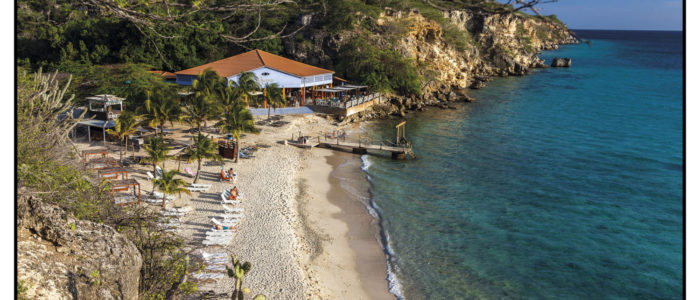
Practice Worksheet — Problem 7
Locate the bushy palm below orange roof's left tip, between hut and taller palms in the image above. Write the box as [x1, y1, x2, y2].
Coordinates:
[144, 86, 182, 136]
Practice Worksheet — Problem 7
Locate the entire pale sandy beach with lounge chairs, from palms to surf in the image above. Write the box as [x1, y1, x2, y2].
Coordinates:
[77, 115, 393, 299]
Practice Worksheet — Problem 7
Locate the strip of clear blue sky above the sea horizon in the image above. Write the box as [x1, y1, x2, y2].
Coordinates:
[500, 0, 683, 30]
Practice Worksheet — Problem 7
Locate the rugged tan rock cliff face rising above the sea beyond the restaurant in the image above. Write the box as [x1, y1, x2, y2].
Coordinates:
[285, 8, 577, 119]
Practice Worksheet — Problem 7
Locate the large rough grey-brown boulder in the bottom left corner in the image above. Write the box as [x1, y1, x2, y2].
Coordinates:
[17, 197, 142, 299]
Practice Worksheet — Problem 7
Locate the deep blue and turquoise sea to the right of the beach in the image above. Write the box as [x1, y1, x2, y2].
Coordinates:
[364, 31, 683, 299]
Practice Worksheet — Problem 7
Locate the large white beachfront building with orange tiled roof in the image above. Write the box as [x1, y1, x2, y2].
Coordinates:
[175, 50, 334, 106]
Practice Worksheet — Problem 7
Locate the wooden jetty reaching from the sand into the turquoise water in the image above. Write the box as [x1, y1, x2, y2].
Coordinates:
[285, 121, 416, 159]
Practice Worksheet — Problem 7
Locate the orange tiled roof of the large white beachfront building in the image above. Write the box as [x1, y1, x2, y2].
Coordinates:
[175, 49, 333, 77]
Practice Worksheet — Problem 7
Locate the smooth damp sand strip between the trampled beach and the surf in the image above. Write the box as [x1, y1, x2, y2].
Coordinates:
[297, 149, 396, 299]
